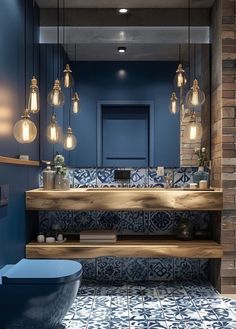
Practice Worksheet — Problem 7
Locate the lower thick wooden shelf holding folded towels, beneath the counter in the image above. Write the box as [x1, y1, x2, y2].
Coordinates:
[26, 238, 223, 259]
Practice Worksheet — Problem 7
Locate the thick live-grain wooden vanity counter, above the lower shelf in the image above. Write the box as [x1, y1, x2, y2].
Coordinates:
[26, 188, 223, 211]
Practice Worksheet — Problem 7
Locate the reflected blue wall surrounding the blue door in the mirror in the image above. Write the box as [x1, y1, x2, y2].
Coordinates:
[68, 62, 180, 167]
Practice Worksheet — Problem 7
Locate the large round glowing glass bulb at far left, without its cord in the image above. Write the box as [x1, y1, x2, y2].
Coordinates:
[13, 110, 37, 144]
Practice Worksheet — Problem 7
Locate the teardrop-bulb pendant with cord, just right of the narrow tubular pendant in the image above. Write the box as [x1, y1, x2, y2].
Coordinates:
[47, 0, 65, 108]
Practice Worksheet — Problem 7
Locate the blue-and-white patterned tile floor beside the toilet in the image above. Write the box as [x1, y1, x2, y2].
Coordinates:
[63, 281, 236, 329]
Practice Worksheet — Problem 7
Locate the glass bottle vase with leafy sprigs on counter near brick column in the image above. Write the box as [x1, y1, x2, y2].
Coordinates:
[193, 147, 209, 187]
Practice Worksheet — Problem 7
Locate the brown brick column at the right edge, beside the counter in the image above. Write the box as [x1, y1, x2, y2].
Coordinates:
[211, 0, 236, 293]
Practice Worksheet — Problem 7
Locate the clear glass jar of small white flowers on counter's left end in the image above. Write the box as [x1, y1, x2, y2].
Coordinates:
[54, 154, 70, 190]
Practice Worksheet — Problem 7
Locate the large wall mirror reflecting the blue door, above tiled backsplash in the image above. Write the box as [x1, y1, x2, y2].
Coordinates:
[39, 0, 213, 167]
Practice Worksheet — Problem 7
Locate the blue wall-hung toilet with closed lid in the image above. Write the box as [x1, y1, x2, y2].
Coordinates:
[0, 259, 82, 329]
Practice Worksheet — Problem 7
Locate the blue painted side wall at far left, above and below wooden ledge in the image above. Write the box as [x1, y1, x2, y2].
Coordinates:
[0, 0, 39, 266]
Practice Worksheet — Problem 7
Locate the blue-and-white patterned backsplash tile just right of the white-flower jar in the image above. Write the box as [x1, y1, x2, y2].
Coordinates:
[73, 168, 97, 188]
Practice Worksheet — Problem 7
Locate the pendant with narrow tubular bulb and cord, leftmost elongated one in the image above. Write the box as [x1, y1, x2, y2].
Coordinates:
[28, 0, 40, 114]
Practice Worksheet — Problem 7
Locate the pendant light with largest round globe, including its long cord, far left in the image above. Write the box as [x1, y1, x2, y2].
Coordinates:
[13, 0, 37, 144]
